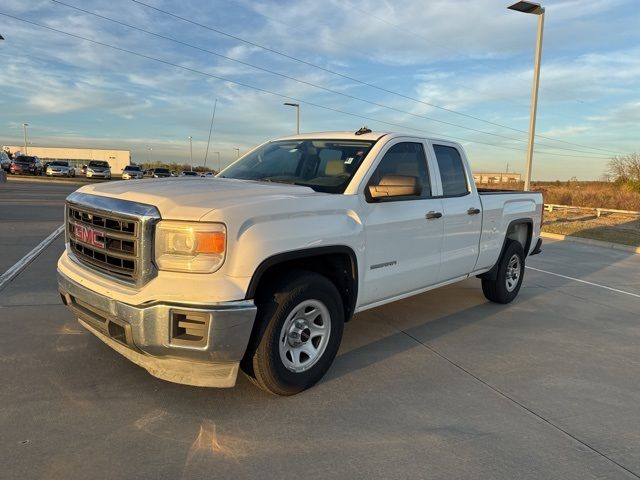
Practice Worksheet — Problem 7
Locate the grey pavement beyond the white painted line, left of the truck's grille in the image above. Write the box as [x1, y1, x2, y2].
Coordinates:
[0, 179, 80, 274]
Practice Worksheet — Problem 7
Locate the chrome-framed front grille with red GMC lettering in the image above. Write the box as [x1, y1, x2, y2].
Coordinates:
[66, 193, 159, 285]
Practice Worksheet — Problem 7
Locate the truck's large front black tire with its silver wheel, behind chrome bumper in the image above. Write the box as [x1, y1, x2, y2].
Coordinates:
[241, 271, 344, 395]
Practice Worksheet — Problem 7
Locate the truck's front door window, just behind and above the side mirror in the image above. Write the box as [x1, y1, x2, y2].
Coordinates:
[369, 142, 431, 197]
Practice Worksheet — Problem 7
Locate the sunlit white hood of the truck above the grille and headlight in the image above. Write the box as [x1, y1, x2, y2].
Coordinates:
[78, 178, 324, 221]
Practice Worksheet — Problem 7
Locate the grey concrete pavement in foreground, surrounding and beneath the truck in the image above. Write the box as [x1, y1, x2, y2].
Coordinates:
[0, 182, 640, 480]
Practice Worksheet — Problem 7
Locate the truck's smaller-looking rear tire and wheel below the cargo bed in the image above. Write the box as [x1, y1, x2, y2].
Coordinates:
[482, 240, 524, 304]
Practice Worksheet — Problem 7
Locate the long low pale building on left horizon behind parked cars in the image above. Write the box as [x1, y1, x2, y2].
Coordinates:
[2, 145, 131, 175]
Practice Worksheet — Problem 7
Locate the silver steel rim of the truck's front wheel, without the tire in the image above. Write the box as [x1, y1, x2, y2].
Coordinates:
[278, 300, 331, 373]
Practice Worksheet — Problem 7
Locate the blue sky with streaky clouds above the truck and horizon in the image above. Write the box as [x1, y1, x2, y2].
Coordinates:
[0, 0, 640, 180]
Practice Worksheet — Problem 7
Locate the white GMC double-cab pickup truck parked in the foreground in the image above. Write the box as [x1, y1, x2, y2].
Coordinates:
[58, 129, 543, 395]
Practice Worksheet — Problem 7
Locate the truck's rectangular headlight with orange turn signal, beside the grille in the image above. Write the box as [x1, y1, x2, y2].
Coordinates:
[155, 221, 227, 273]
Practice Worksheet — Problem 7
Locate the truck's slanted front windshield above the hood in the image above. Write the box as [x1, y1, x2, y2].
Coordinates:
[219, 140, 374, 193]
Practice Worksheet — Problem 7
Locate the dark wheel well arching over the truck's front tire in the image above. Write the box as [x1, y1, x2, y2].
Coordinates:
[245, 247, 358, 321]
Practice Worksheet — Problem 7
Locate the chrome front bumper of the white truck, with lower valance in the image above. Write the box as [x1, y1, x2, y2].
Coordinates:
[58, 271, 256, 387]
